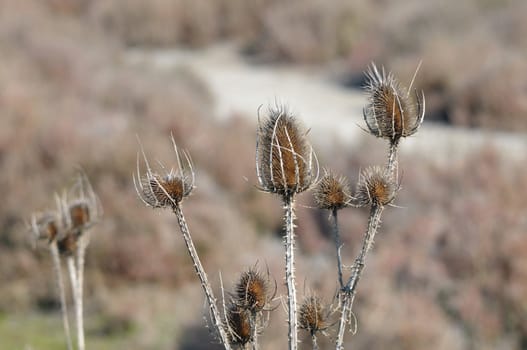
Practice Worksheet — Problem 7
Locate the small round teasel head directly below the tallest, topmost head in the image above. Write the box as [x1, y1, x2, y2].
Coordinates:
[356, 166, 398, 206]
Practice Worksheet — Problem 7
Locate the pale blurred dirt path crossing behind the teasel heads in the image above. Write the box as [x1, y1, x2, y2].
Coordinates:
[126, 46, 527, 164]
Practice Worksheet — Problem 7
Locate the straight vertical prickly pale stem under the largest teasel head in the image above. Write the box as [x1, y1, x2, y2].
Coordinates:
[284, 195, 298, 350]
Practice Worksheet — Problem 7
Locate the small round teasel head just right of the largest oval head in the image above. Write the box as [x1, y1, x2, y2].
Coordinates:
[313, 171, 350, 210]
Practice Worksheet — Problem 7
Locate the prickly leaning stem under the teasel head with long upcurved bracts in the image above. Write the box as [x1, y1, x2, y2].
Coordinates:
[173, 205, 231, 350]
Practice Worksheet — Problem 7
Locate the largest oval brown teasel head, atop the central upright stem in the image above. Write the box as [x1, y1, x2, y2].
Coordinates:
[256, 107, 318, 196]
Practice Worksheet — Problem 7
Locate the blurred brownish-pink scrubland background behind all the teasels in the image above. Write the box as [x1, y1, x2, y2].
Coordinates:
[0, 0, 527, 350]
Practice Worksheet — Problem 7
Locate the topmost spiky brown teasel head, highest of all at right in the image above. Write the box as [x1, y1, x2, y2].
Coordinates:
[363, 63, 425, 144]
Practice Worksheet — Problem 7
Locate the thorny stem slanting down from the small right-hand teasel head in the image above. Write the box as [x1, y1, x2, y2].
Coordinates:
[336, 204, 384, 350]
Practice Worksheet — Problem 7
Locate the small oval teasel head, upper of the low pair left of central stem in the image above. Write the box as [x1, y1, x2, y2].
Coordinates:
[236, 268, 269, 313]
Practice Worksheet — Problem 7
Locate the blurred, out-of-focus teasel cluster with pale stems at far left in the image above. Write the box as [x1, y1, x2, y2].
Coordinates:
[28, 173, 102, 350]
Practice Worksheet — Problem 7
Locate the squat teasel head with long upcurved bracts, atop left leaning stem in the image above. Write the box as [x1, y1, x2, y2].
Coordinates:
[134, 136, 194, 208]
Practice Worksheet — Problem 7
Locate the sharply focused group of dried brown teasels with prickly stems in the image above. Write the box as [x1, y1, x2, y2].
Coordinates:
[134, 64, 425, 350]
